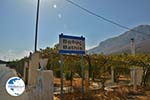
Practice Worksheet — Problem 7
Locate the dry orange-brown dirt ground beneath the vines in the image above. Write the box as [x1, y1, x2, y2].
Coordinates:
[54, 77, 150, 100]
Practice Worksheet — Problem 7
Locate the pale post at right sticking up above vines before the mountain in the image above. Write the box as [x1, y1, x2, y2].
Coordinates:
[131, 38, 137, 91]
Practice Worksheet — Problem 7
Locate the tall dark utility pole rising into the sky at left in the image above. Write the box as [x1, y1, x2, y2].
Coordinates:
[34, 0, 40, 52]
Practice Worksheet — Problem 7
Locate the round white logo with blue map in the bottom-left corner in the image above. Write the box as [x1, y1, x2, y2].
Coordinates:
[6, 77, 25, 96]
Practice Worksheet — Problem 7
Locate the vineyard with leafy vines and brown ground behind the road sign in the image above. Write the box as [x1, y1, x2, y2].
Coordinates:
[9, 45, 150, 100]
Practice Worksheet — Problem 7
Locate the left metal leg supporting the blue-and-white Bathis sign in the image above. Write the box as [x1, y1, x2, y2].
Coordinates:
[60, 54, 63, 100]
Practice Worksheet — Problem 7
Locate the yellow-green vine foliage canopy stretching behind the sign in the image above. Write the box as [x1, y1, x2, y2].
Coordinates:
[8, 44, 150, 84]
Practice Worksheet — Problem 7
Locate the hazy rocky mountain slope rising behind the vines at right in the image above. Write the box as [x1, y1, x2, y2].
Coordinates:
[88, 25, 150, 54]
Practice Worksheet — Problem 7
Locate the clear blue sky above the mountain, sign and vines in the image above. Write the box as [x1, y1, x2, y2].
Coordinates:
[0, 0, 150, 60]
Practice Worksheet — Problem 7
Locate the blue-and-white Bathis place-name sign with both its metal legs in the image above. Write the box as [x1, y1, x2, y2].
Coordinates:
[59, 34, 85, 100]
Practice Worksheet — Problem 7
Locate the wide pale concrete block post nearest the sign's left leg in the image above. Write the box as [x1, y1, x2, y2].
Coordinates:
[36, 69, 54, 100]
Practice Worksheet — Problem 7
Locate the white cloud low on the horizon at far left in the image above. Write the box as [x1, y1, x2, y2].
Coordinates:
[0, 50, 31, 61]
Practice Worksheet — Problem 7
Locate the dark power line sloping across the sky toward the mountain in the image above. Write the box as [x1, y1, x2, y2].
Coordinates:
[65, 0, 146, 34]
